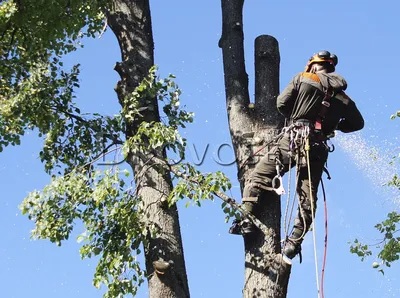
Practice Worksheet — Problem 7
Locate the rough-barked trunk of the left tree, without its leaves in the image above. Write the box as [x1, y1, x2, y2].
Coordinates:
[107, 0, 190, 298]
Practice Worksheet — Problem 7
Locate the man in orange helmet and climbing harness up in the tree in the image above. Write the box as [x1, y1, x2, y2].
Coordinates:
[229, 51, 364, 259]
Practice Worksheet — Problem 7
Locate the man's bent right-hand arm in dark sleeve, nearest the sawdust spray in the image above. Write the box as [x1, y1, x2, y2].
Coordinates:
[337, 92, 364, 133]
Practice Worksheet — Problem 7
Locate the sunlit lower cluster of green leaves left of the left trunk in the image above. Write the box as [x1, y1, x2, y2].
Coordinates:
[21, 168, 148, 297]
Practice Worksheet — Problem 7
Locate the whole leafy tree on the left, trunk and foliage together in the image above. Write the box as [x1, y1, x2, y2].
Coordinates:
[0, 0, 191, 297]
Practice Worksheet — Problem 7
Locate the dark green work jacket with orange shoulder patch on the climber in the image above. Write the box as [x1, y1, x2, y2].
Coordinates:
[277, 72, 364, 135]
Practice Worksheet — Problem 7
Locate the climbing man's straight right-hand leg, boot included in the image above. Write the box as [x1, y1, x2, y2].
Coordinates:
[283, 145, 328, 259]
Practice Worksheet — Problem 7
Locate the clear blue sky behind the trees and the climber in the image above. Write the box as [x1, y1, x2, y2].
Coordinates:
[0, 0, 400, 298]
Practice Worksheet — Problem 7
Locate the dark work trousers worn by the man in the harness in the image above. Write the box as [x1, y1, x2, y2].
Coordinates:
[243, 132, 328, 244]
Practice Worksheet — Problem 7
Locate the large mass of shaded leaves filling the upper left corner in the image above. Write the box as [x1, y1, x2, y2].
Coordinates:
[0, 0, 115, 174]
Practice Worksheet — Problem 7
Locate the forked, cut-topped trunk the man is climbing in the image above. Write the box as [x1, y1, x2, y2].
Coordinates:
[219, 0, 291, 298]
